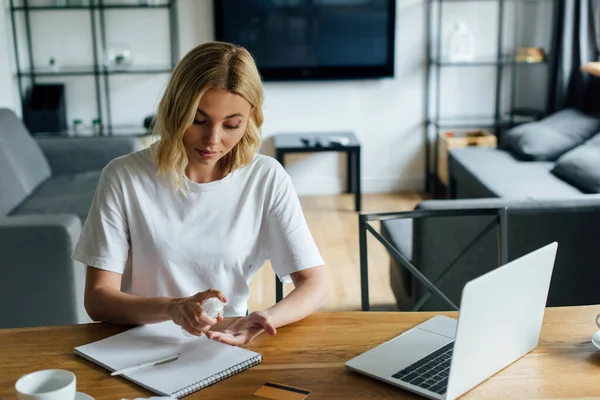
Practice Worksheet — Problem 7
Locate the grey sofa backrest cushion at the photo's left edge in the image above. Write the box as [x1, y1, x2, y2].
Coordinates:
[0, 109, 50, 215]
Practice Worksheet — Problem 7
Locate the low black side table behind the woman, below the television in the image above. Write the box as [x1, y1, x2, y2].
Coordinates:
[273, 132, 361, 212]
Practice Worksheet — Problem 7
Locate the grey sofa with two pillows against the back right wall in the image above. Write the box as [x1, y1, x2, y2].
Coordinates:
[449, 109, 600, 199]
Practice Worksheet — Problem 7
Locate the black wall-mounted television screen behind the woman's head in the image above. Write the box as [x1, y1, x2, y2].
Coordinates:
[213, 0, 396, 81]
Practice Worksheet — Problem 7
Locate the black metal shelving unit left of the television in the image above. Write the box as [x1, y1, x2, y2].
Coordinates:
[9, 0, 179, 136]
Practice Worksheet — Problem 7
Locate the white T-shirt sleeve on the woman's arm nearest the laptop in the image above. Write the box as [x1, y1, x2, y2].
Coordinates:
[266, 169, 324, 283]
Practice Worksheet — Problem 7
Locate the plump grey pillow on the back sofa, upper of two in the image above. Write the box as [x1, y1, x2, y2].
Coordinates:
[506, 109, 600, 161]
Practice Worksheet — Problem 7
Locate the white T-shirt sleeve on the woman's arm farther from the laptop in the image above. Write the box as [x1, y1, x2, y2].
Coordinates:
[72, 167, 130, 274]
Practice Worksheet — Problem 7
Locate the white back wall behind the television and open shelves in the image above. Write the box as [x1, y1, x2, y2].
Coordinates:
[0, 0, 552, 195]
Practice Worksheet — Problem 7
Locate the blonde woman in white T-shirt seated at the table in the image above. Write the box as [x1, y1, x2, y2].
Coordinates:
[73, 42, 328, 345]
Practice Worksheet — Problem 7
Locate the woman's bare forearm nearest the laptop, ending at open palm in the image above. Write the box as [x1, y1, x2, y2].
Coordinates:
[265, 277, 329, 328]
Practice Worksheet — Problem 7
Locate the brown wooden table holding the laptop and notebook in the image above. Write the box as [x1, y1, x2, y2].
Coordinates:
[0, 306, 600, 400]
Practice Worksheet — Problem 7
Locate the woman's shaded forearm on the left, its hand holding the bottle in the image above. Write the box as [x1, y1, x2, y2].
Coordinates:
[85, 287, 178, 324]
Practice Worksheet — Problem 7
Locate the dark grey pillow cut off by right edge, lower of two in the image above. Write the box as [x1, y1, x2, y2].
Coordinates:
[552, 134, 600, 193]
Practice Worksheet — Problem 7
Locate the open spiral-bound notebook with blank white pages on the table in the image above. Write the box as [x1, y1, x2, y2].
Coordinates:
[75, 321, 262, 398]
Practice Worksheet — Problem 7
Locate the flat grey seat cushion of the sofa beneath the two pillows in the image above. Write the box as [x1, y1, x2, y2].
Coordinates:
[450, 147, 582, 198]
